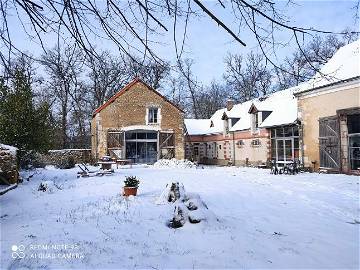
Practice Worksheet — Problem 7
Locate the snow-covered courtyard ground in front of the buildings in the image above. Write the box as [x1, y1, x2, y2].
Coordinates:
[0, 166, 360, 269]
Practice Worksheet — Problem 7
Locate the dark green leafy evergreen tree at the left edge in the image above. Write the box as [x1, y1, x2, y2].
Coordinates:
[0, 69, 52, 155]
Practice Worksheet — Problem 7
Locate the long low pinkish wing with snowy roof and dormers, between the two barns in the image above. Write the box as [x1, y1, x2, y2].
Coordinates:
[185, 88, 300, 166]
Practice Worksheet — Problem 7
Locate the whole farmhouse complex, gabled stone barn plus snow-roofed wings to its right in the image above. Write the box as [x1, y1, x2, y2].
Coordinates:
[91, 41, 360, 173]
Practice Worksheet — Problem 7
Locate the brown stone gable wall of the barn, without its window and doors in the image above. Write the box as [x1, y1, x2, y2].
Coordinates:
[91, 82, 184, 159]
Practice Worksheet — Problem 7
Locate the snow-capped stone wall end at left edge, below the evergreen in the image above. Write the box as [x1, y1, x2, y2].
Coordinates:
[0, 144, 19, 185]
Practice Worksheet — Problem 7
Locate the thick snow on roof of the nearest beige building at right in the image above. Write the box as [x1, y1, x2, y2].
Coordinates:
[297, 39, 360, 93]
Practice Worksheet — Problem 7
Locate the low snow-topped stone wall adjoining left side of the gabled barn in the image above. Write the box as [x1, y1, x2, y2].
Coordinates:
[41, 149, 93, 166]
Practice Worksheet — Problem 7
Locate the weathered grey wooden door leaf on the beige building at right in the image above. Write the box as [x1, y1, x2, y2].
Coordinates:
[319, 116, 340, 170]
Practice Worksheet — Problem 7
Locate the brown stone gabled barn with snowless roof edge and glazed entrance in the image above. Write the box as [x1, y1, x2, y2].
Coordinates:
[91, 78, 184, 163]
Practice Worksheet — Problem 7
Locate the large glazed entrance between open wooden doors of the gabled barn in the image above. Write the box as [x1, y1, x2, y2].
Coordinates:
[125, 131, 158, 164]
